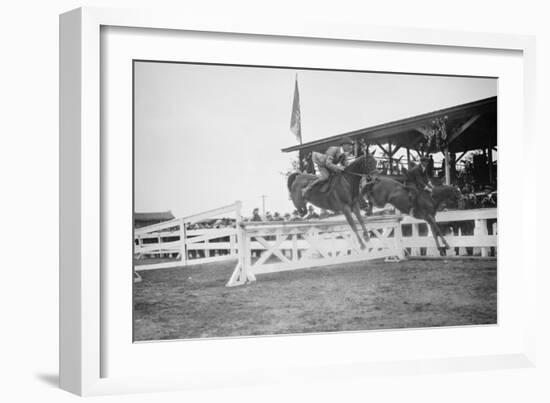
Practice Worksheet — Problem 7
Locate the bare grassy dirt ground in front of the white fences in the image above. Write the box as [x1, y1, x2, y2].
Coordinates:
[134, 259, 497, 341]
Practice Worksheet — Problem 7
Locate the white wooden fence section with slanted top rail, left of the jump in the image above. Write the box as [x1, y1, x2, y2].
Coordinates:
[134, 201, 241, 271]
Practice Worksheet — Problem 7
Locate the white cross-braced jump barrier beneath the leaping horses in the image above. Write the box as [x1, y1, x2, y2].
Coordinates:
[226, 215, 404, 287]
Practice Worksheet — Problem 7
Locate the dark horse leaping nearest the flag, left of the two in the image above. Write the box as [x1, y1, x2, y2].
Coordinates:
[287, 153, 376, 249]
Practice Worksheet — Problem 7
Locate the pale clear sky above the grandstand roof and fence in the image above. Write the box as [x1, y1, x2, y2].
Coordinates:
[134, 62, 497, 217]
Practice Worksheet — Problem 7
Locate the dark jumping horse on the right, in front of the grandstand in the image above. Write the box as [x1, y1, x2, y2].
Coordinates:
[362, 178, 461, 256]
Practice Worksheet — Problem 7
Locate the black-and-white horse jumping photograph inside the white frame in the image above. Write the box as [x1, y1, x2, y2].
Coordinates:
[133, 60, 498, 342]
